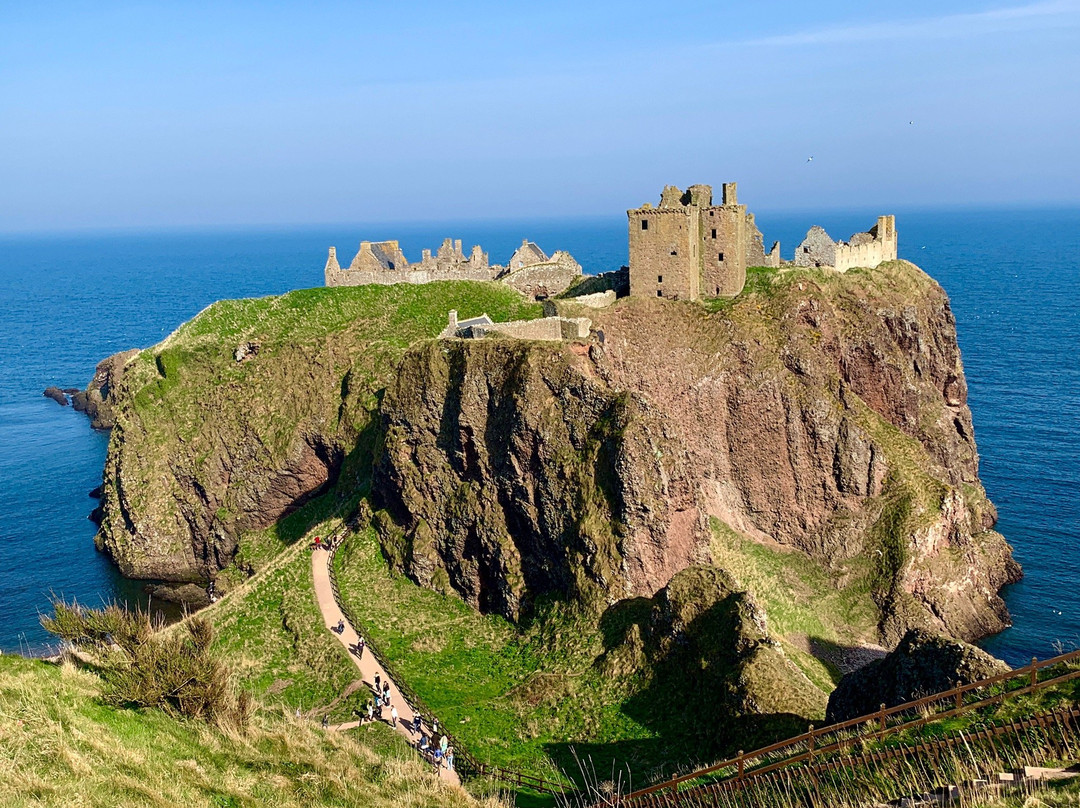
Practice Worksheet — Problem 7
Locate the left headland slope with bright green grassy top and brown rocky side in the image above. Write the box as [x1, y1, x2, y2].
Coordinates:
[93, 282, 539, 582]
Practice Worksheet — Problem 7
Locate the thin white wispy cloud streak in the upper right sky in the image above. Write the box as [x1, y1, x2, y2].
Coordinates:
[741, 0, 1080, 48]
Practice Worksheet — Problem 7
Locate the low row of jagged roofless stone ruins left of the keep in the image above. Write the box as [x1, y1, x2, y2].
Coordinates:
[323, 239, 581, 299]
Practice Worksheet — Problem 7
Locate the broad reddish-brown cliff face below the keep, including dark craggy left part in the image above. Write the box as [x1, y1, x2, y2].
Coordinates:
[374, 261, 1020, 645]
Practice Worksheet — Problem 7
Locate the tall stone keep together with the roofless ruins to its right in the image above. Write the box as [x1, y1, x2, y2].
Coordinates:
[626, 183, 896, 300]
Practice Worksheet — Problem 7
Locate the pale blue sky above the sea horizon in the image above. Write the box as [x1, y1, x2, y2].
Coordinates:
[0, 0, 1080, 231]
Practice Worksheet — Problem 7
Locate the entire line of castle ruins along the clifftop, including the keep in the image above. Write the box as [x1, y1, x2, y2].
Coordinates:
[324, 183, 896, 308]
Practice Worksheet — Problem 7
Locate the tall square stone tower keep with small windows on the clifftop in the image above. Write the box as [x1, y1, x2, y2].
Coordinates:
[626, 183, 780, 300]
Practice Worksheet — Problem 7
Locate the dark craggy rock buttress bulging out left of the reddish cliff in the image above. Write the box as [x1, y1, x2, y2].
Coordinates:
[374, 340, 705, 619]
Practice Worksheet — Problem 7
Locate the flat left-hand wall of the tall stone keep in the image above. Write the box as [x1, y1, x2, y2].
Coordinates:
[626, 205, 701, 300]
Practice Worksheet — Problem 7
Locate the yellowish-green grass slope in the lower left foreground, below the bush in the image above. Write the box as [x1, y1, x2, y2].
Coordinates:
[0, 657, 483, 808]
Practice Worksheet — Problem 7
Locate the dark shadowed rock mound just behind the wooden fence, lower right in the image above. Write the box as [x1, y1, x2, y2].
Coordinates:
[825, 629, 1009, 724]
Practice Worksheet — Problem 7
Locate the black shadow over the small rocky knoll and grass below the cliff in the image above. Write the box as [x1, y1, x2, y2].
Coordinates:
[545, 593, 810, 787]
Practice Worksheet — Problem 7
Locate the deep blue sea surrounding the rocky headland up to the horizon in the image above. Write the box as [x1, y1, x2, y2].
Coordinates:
[0, 210, 1080, 664]
